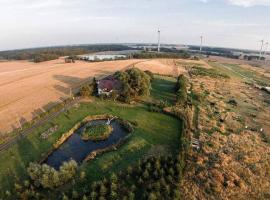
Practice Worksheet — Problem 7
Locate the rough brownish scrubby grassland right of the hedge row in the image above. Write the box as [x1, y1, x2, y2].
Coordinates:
[182, 59, 270, 199]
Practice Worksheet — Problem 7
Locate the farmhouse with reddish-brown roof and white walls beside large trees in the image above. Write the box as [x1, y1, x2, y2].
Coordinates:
[97, 75, 122, 96]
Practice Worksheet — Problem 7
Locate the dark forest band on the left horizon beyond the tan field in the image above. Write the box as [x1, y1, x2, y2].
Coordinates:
[0, 44, 134, 62]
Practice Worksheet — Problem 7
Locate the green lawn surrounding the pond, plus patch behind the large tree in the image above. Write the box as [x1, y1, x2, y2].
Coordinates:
[0, 75, 182, 195]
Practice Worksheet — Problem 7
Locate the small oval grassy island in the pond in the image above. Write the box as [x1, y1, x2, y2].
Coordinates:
[81, 124, 113, 141]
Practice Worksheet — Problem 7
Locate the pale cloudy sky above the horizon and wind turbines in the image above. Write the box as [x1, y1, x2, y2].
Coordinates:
[0, 0, 270, 50]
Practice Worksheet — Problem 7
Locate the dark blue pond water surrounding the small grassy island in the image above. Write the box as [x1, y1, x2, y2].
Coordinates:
[44, 120, 128, 169]
